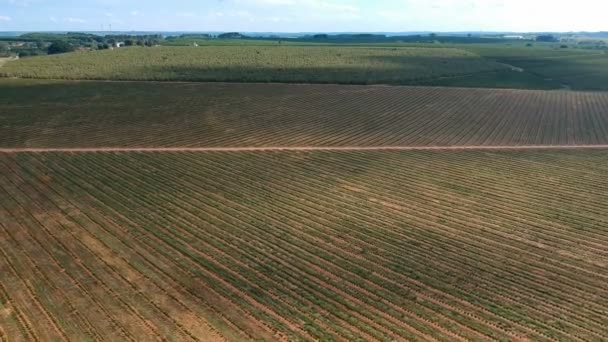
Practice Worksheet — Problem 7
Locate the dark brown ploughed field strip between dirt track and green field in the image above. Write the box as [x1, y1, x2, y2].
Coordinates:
[0, 80, 608, 148]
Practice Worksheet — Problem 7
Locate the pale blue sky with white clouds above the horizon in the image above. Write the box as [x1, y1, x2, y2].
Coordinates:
[0, 0, 608, 32]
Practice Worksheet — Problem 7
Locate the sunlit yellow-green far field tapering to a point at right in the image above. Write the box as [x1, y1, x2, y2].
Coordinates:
[0, 45, 508, 84]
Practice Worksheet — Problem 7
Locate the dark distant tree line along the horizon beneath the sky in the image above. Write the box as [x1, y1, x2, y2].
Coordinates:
[0, 32, 608, 57]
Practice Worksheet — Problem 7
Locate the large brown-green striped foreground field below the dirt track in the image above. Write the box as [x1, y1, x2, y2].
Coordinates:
[0, 151, 608, 341]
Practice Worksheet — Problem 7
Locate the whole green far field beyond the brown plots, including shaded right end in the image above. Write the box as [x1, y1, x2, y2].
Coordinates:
[0, 40, 608, 90]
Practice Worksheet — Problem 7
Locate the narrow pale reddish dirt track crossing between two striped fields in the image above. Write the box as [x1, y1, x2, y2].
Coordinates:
[0, 145, 608, 153]
